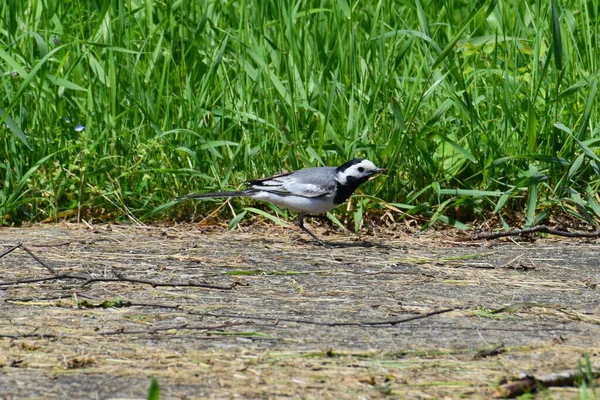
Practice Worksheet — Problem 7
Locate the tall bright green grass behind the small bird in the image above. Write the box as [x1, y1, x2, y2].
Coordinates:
[0, 0, 600, 230]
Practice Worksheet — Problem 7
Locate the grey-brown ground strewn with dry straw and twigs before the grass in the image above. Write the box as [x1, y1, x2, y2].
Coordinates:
[0, 224, 600, 399]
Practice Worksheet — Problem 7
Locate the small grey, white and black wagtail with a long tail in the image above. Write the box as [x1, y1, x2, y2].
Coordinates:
[176, 158, 387, 244]
